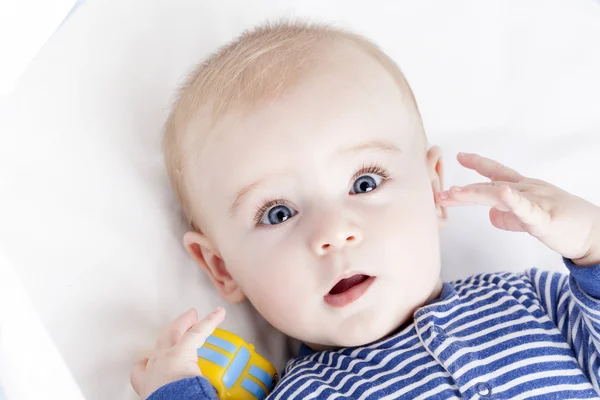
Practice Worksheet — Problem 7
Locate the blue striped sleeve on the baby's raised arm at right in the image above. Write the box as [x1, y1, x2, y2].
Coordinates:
[525, 259, 600, 388]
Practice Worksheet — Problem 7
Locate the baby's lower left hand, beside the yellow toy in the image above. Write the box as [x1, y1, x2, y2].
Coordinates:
[131, 307, 225, 400]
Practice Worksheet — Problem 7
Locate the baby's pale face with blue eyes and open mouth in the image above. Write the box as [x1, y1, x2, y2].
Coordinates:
[188, 45, 441, 347]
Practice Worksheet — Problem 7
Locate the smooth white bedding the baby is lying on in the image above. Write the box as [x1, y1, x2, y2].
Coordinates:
[0, 0, 600, 399]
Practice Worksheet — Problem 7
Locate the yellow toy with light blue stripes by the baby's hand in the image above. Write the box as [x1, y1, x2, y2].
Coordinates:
[198, 328, 279, 400]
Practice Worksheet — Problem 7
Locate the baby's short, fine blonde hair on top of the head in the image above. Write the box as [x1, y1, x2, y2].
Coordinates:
[163, 21, 418, 230]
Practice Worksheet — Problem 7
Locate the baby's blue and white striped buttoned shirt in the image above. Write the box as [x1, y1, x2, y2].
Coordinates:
[151, 260, 600, 400]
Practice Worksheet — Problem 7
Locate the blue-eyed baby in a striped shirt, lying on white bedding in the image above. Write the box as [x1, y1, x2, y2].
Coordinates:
[131, 23, 600, 400]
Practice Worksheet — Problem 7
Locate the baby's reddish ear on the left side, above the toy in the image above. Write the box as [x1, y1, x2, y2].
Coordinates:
[183, 231, 246, 304]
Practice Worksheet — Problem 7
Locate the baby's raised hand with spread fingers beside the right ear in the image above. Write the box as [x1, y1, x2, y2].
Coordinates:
[437, 153, 600, 266]
